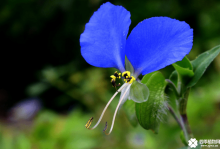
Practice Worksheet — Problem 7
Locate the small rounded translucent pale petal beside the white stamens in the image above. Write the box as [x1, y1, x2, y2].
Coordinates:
[129, 81, 149, 103]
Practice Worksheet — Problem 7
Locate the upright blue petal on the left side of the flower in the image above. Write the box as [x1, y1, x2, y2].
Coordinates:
[80, 2, 131, 71]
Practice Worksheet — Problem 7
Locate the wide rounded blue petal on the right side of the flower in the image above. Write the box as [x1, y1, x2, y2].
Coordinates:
[125, 17, 193, 75]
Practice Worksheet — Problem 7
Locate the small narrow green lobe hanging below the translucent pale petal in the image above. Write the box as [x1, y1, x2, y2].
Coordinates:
[123, 100, 138, 127]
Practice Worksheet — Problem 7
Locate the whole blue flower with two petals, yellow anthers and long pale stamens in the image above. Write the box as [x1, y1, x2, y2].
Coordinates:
[80, 2, 193, 132]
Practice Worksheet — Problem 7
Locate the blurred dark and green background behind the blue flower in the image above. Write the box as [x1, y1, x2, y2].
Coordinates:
[0, 0, 220, 149]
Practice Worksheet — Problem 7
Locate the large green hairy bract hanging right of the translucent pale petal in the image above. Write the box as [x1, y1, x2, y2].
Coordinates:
[135, 71, 167, 133]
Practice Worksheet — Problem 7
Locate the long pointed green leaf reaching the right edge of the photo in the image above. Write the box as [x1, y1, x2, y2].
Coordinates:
[187, 45, 220, 87]
